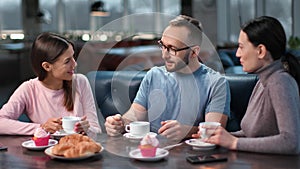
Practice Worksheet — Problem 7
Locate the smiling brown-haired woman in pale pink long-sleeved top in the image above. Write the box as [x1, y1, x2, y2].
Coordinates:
[0, 33, 101, 135]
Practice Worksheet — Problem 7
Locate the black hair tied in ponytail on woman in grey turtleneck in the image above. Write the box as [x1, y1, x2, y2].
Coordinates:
[242, 16, 300, 92]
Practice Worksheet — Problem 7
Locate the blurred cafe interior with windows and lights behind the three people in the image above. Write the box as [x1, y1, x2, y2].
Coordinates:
[0, 0, 300, 107]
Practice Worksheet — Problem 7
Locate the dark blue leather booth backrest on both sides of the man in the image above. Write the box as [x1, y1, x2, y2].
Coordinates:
[87, 71, 258, 131]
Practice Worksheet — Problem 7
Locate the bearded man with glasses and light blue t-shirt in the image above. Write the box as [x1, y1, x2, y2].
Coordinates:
[105, 15, 230, 141]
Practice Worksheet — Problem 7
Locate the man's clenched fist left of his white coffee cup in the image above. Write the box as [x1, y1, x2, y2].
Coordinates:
[104, 114, 125, 136]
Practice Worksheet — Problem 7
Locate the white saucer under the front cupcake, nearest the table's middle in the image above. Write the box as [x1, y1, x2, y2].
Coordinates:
[129, 148, 169, 161]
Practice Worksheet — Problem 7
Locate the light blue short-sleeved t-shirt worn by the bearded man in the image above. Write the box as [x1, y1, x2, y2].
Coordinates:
[134, 64, 230, 132]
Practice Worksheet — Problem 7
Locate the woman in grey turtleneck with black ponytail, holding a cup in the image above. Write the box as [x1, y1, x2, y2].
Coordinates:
[195, 16, 300, 154]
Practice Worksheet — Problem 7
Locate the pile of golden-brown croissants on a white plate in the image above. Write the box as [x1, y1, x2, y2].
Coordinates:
[52, 134, 101, 158]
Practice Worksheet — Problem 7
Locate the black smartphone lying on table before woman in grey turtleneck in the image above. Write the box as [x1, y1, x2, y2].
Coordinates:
[186, 155, 227, 164]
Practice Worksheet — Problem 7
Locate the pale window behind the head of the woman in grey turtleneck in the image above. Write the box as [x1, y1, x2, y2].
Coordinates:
[217, 0, 290, 47]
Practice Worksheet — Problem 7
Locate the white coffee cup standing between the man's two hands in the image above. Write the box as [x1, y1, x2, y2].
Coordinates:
[125, 121, 150, 136]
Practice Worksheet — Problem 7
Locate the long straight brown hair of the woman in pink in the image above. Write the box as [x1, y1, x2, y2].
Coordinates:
[31, 32, 74, 111]
